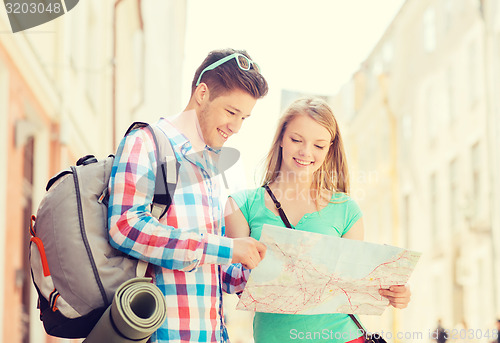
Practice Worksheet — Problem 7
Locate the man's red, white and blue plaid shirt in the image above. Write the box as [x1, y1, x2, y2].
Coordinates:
[108, 119, 249, 342]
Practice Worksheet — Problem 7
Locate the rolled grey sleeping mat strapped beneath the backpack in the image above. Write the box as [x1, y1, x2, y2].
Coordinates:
[83, 278, 167, 343]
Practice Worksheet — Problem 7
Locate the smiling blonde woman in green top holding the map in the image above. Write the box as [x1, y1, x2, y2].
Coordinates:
[226, 98, 410, 343]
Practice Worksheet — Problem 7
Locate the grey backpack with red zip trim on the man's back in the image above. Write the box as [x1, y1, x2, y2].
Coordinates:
[30, 122, 179, 338]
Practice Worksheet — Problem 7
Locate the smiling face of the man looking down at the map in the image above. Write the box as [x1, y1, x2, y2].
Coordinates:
[197, 89, 257, 149]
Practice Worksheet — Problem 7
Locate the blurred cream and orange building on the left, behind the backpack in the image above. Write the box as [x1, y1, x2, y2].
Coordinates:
[0, 0, 186, 343]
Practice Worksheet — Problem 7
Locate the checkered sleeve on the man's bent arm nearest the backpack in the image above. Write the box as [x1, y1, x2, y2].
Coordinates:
[108, 129, 233, 271]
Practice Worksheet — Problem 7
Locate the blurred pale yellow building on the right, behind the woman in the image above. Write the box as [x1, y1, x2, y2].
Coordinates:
[334, 0, 500, 341]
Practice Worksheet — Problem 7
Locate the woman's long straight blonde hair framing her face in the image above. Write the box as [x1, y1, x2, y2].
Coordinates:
[263, 97, 350, 202]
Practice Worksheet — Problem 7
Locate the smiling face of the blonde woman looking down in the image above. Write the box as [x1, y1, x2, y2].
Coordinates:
[280, 115, 332, 181]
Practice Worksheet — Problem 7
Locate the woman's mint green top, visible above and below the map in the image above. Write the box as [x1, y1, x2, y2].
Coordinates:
[231, 187, 361, 343]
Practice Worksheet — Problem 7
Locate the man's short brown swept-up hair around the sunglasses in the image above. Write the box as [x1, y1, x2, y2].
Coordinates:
[191, 49, 268, 100]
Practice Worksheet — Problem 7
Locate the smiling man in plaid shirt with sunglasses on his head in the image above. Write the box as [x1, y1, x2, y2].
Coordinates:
[108, 49, 268, 342]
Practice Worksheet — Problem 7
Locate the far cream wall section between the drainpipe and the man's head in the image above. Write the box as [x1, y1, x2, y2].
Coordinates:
[115, 0, 188, 142]
